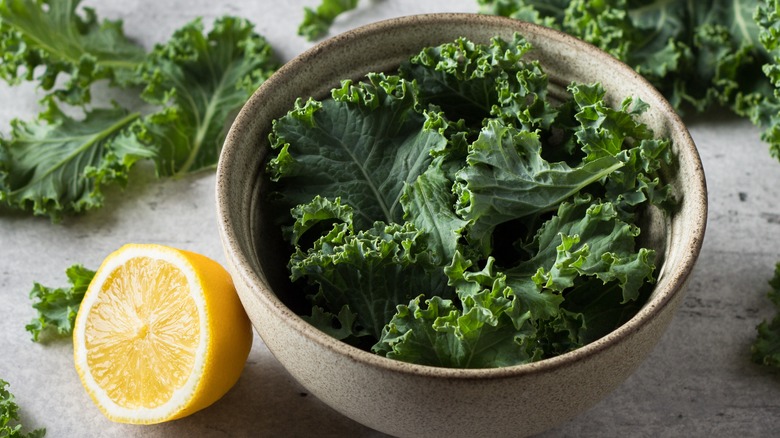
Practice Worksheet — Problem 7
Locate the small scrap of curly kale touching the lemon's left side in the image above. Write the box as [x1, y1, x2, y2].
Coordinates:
[25, 265, 95, 342]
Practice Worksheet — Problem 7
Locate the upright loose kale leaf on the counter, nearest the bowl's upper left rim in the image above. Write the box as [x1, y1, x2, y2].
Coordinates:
[138, 16, 277, 176]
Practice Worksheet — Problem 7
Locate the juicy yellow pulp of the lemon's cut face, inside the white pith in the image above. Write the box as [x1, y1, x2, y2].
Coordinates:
[85, 257, 200, 409]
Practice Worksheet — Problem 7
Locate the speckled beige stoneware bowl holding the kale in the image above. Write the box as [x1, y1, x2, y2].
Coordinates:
[217, 14, 707, 438]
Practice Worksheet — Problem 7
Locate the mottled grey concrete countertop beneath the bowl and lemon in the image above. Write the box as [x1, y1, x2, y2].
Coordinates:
[0, 0, 780, 437]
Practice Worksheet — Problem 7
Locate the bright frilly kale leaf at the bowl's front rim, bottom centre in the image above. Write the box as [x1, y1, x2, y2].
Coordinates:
[372, 260, 539, 368]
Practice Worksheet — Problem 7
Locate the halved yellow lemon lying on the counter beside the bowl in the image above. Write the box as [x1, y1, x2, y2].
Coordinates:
[73, 244, 252, 424]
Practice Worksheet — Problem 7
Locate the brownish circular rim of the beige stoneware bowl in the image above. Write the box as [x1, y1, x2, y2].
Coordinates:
[216, 13, 708, 380]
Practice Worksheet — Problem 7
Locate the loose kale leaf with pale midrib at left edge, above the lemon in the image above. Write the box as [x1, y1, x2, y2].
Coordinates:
[0, 101, 154, 221]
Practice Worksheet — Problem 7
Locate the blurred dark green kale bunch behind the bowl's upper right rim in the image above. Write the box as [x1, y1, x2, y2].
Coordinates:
[479, 0, 771, 111]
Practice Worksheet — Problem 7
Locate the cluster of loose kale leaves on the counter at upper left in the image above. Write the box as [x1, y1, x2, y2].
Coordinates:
[0, 10, 278, 221]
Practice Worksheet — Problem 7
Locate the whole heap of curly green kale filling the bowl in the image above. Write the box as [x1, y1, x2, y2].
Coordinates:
[265, 36, 671, 367]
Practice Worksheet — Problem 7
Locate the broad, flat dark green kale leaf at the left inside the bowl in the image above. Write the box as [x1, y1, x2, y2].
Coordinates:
[268, 74, 447, 229]
